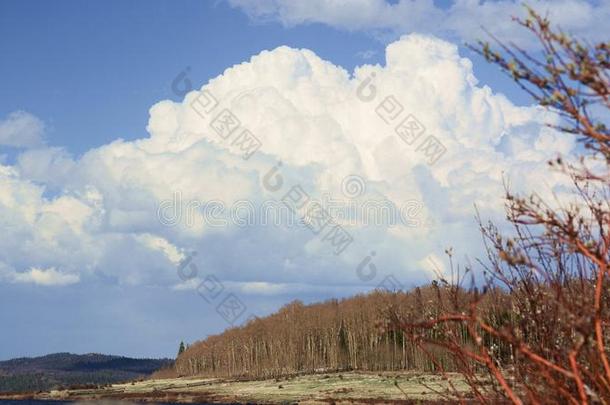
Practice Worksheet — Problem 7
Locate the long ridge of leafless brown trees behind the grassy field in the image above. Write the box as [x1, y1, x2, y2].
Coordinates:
[176, 283, 511, 378]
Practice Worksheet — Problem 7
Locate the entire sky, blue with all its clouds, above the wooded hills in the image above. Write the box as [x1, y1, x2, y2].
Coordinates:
[0, 0, 609, 359]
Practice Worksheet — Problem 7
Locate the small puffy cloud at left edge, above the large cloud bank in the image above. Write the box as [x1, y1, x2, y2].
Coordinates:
[0, 111, 44, 148]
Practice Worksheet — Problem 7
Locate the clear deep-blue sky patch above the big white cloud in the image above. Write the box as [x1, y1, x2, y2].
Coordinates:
[0, 0, 527, 154]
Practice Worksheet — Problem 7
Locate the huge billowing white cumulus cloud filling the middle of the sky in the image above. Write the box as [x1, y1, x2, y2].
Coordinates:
[0, 35, 573, 294]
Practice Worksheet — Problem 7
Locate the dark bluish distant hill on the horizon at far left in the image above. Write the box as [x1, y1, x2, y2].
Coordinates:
[0, 353, 173, 392]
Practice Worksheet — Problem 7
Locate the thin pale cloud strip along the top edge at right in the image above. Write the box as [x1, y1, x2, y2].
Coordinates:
[229, 0, 610, 47]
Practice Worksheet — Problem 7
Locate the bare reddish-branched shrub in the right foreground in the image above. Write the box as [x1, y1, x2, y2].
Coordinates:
[390, 8, 610, 404]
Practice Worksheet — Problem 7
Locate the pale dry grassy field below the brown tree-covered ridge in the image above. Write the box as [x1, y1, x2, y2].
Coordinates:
[0, 372, 468, 404]
